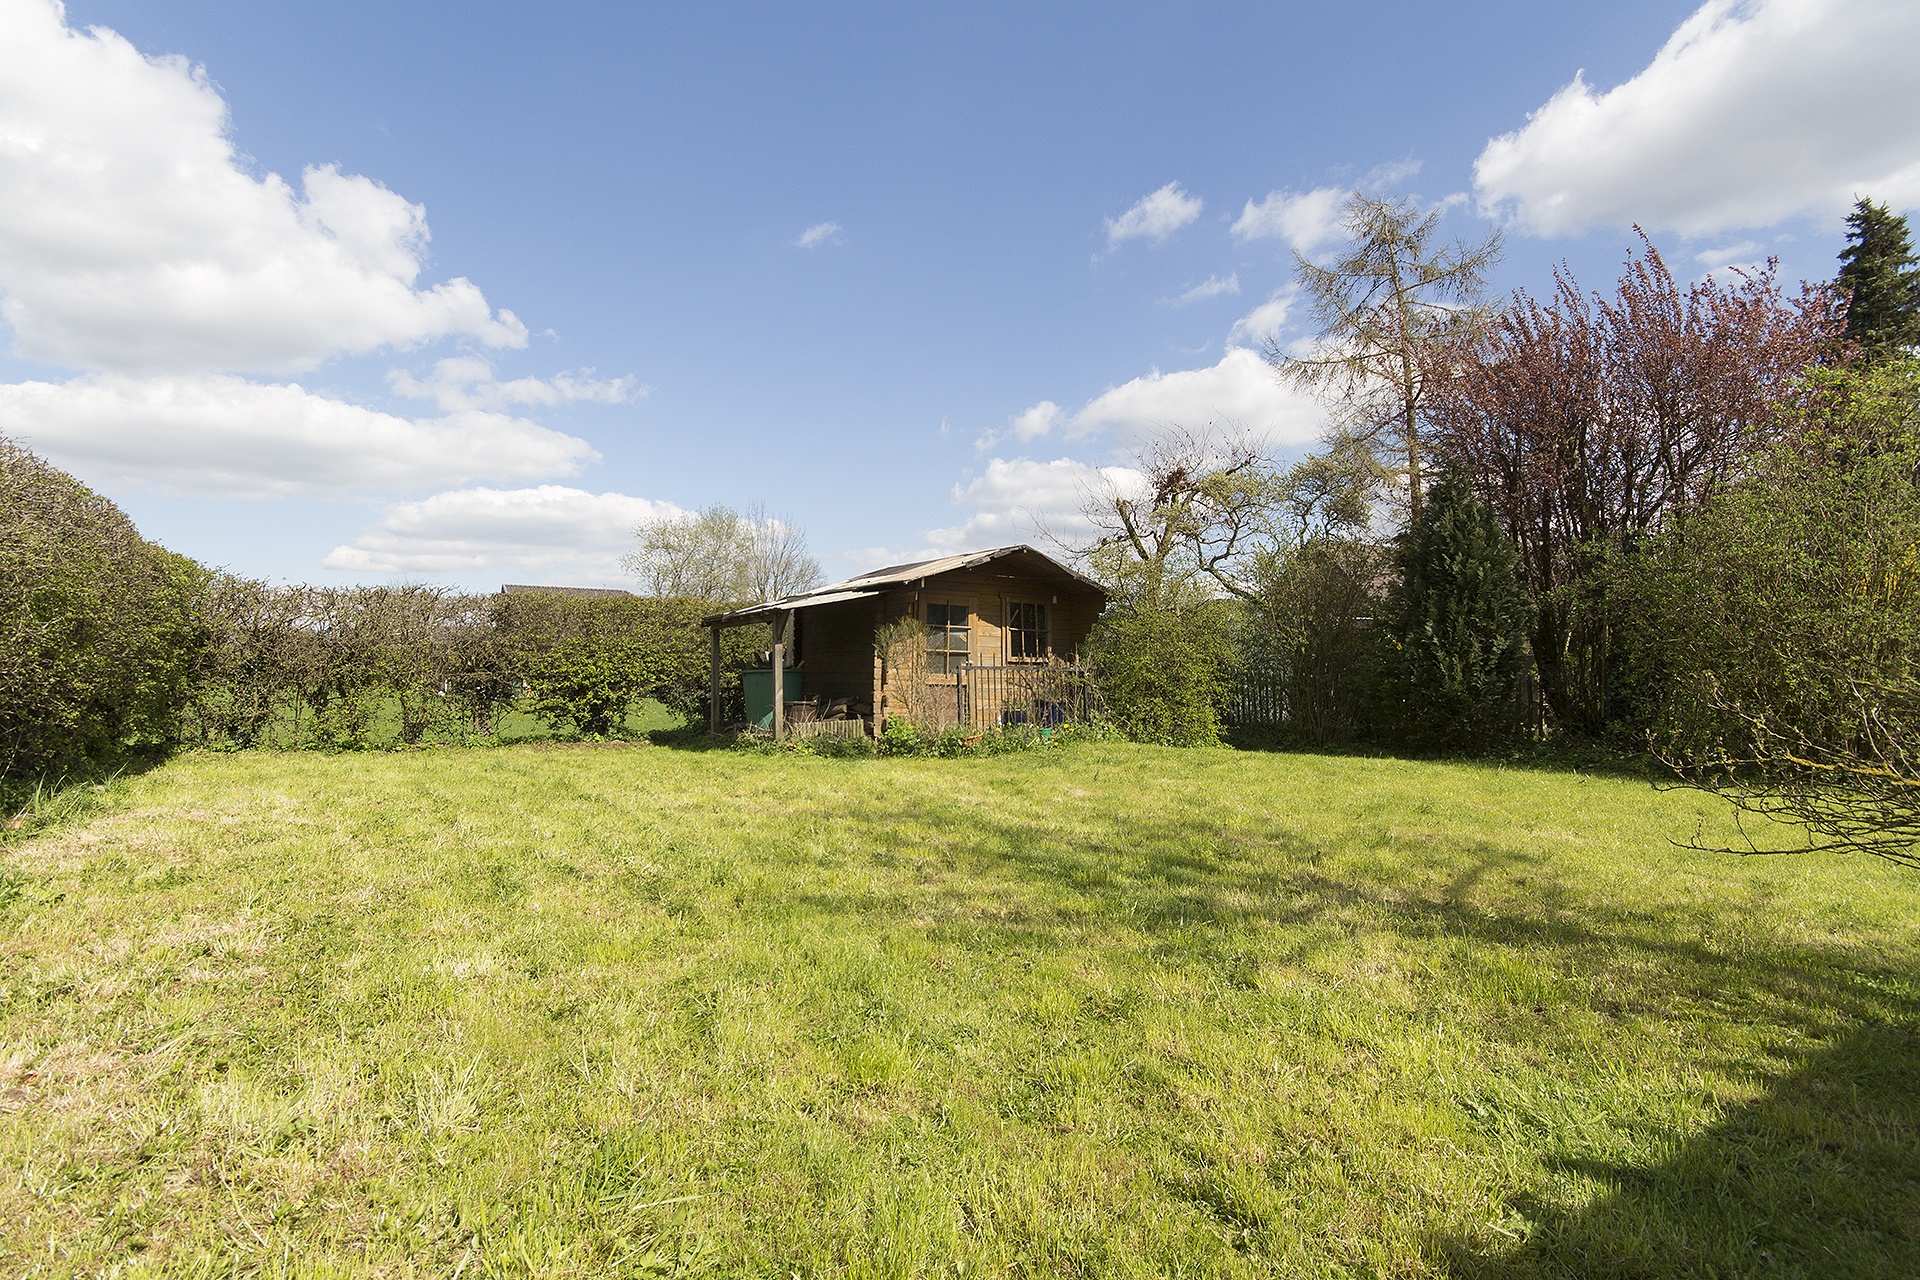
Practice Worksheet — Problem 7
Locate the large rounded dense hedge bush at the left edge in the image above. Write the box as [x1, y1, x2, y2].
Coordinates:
[0, 439, 205, 785]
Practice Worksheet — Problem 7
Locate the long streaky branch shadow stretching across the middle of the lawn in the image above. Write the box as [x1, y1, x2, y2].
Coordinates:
[787, 796, 1920, 1028]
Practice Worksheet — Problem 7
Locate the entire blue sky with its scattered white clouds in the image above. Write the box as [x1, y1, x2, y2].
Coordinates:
[0, 0, 1920, 587]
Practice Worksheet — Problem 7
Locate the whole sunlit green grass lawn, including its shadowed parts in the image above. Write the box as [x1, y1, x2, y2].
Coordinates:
[0, 745, 1920, 1278]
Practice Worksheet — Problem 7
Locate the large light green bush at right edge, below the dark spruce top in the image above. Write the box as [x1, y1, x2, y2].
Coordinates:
[1622, 361, 1920, 862]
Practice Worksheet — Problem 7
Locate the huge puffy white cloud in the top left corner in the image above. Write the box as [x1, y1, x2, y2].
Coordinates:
[0, 0, 526, 372]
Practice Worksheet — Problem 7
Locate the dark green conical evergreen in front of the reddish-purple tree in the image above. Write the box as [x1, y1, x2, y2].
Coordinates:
[1390, 476, 1528, 748]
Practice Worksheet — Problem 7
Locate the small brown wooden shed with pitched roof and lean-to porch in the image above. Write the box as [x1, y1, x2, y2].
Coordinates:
[703, 545, 1106, 737]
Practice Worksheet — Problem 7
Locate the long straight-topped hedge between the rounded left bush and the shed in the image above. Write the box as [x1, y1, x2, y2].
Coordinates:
[186, 574, 753, 750]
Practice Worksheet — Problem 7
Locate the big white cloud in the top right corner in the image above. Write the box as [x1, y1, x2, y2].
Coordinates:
[1475, 0, 1920, 236]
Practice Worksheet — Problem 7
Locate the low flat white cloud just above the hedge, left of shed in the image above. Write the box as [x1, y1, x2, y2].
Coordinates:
[324, 484, 685, 585]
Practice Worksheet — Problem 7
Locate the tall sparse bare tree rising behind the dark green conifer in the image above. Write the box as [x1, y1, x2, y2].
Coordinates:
[1267, 192, 1500, 524]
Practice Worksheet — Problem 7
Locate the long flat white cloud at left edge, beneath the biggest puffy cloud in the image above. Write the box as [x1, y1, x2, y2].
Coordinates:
[0, 374, 599, 497]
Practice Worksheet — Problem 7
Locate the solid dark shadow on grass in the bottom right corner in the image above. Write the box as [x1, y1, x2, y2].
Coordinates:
[1428, 1021, 1920, 1280]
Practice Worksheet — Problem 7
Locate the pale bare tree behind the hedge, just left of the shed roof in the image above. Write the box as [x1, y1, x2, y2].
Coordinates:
[620, 505, 820, 603]
